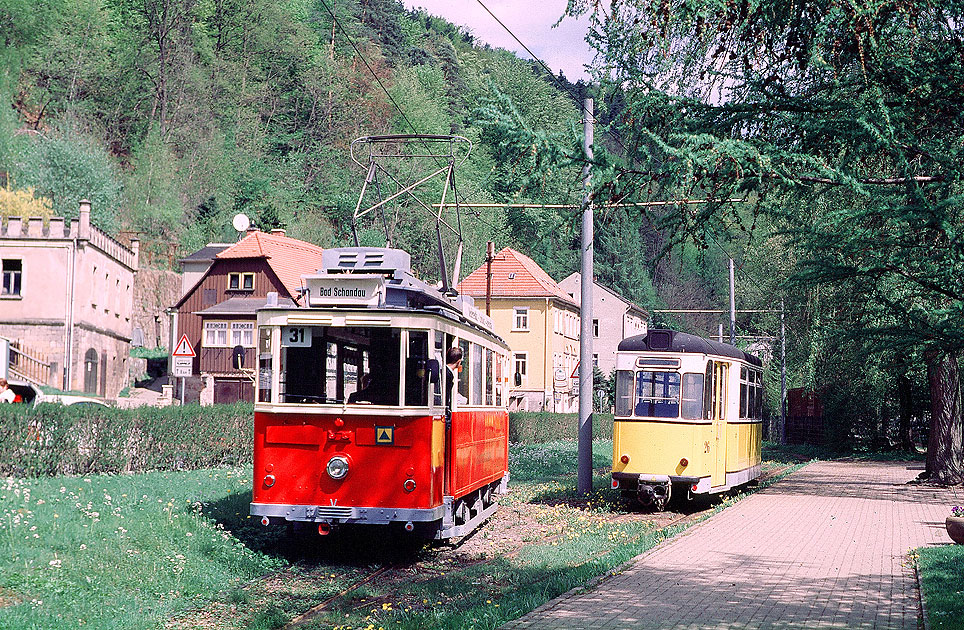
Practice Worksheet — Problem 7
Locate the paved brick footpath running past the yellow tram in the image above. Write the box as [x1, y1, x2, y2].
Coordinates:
[503, 461, 964, 630]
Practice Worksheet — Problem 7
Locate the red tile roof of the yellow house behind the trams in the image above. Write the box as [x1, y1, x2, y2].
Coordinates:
[458, 247, 576, 305]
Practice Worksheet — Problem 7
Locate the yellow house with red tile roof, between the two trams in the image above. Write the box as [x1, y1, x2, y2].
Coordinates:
[459, 247, 579, 412]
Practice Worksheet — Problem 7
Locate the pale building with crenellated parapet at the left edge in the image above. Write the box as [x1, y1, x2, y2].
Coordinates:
[0, 201, 138, 398]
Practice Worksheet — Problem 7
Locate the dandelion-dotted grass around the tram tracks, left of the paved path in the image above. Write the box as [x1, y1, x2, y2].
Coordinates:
[0, 440, 799, 629]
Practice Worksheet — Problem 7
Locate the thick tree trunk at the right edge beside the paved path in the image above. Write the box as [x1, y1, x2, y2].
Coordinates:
[925, 350, 964, 485]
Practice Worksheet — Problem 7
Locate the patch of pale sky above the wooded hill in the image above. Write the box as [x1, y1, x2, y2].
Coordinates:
[404, 0, 592, 81]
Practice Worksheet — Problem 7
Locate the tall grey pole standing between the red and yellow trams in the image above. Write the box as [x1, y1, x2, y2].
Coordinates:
[577, 98, 595, 494]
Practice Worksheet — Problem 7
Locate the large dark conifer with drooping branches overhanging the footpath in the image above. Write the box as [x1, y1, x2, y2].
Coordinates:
[569, 0, 964, 483]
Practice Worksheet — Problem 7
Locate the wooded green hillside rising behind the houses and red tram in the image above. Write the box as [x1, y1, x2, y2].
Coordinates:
[0, 0, 740, 316]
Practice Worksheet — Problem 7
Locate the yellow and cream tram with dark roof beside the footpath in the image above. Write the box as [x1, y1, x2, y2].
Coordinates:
[612, 329, 763, 509]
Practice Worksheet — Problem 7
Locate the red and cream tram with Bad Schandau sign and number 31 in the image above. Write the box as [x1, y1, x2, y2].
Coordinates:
[251, 247, 509, 538]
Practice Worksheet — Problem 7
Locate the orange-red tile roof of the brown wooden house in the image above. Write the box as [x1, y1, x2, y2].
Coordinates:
[215, 232, 324, 297]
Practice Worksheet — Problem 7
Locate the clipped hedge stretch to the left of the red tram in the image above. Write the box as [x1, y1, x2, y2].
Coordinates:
[0, 403, 254, 477]
